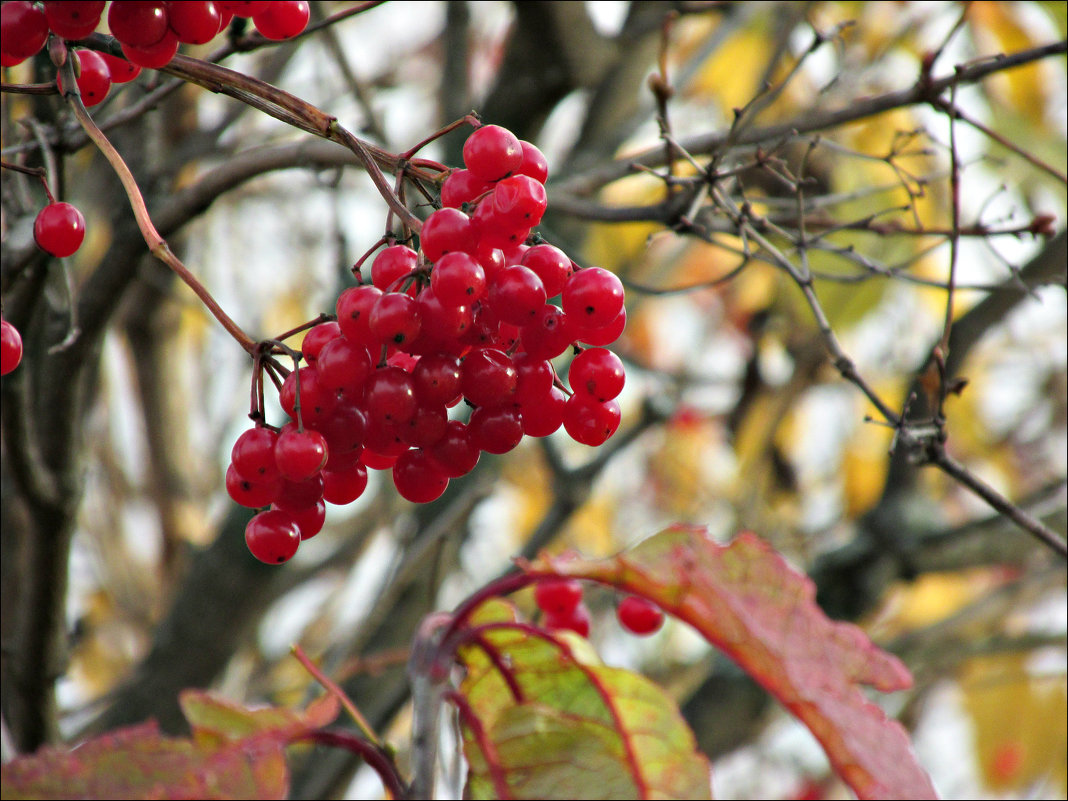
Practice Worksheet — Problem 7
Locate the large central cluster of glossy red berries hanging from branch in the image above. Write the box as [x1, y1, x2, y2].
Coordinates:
[226, 125, 626, 563]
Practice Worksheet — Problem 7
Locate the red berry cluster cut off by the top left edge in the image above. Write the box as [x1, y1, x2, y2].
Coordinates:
[0, 0, 310, 69]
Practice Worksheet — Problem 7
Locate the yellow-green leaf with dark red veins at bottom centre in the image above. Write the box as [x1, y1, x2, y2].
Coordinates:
[458, 601, 711, 799]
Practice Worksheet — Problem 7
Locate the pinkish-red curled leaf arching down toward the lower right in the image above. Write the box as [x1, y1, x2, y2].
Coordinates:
[529, 527, 936, 798]
